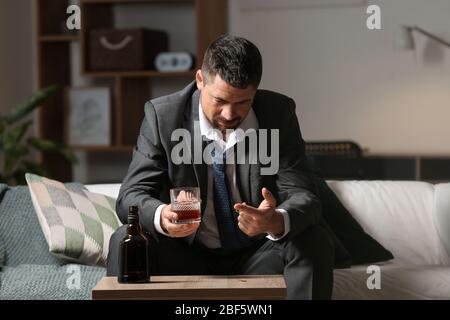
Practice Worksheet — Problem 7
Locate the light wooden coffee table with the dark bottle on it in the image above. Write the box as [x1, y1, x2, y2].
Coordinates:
[92, 275, 286, 300]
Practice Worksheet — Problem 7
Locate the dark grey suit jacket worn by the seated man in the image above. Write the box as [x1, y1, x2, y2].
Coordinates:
[117, 82, 321, 244]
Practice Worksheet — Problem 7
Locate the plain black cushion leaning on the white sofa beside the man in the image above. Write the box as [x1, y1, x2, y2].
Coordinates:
[318, 179, 393, 265]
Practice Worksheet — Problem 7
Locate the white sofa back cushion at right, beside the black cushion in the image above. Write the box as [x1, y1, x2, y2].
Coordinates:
[329, 181, 449, 265]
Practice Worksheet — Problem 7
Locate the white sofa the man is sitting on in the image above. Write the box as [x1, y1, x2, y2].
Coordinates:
[87, 181, 450, 299]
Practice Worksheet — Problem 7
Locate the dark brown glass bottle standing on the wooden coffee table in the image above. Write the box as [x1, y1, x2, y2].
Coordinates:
[118, 206, 150, 283]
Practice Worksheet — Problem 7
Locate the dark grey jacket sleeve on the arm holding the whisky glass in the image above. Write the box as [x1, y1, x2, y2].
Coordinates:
[116, 102, 168, 240]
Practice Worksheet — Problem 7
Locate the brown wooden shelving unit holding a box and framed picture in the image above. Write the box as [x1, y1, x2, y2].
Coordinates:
[36, 0, 227, 181]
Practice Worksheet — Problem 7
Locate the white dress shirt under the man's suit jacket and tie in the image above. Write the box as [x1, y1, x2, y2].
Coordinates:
[154, 103, 290, 249]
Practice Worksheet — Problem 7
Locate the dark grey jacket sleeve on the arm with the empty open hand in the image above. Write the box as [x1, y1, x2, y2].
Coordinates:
[276, 99, 321, 238]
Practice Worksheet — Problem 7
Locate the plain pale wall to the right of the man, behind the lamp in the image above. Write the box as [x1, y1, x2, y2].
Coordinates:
[229, 0, 450, 155]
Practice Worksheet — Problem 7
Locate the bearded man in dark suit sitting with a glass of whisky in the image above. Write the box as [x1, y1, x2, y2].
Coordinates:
[107, 35, 334, 299]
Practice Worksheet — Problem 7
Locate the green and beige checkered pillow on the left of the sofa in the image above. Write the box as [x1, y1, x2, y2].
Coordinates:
[25, 173, 121, 266]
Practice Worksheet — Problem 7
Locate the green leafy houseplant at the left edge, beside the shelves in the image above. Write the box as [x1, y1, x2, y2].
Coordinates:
[0, 85, 77, 185]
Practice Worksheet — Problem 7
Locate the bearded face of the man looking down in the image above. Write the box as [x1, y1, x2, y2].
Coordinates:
[195, 70, 256, 134]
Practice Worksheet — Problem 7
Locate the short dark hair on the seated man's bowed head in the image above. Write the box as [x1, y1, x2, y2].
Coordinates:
[202, 35, 262, 89]
